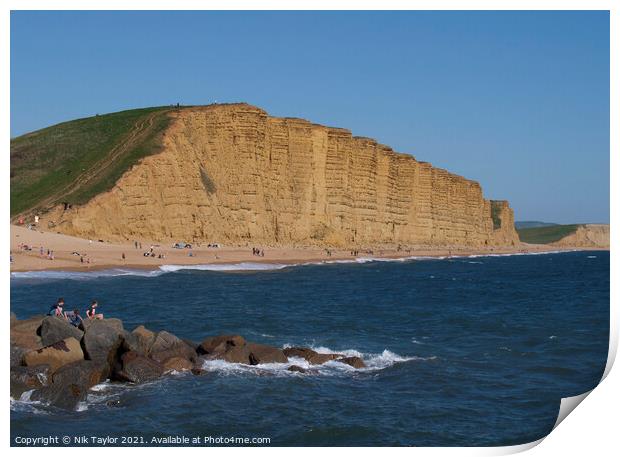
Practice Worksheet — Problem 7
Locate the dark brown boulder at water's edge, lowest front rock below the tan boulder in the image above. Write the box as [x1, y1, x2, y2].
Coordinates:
[30, 360, 107, 410]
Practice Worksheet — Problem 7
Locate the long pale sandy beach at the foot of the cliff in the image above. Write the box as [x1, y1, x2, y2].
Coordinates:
[11, 225, 591, 271]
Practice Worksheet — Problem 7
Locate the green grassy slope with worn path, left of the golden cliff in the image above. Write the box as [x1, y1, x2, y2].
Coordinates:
[11, 107, 171, 216]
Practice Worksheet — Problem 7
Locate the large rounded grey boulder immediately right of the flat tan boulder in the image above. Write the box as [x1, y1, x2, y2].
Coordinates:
[82, 319, 123, 368]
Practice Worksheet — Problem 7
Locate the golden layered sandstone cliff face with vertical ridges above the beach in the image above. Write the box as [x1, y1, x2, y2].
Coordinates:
[42, 104, 518, 246]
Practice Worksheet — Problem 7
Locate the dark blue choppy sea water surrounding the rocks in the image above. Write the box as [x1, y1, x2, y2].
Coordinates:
[11, 251, 610, 446]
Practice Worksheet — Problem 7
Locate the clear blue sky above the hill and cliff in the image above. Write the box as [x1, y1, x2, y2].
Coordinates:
[11, 12, 609, 223]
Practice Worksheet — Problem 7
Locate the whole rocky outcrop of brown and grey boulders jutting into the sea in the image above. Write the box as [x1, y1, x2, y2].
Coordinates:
[11, 316, 365, 409]
